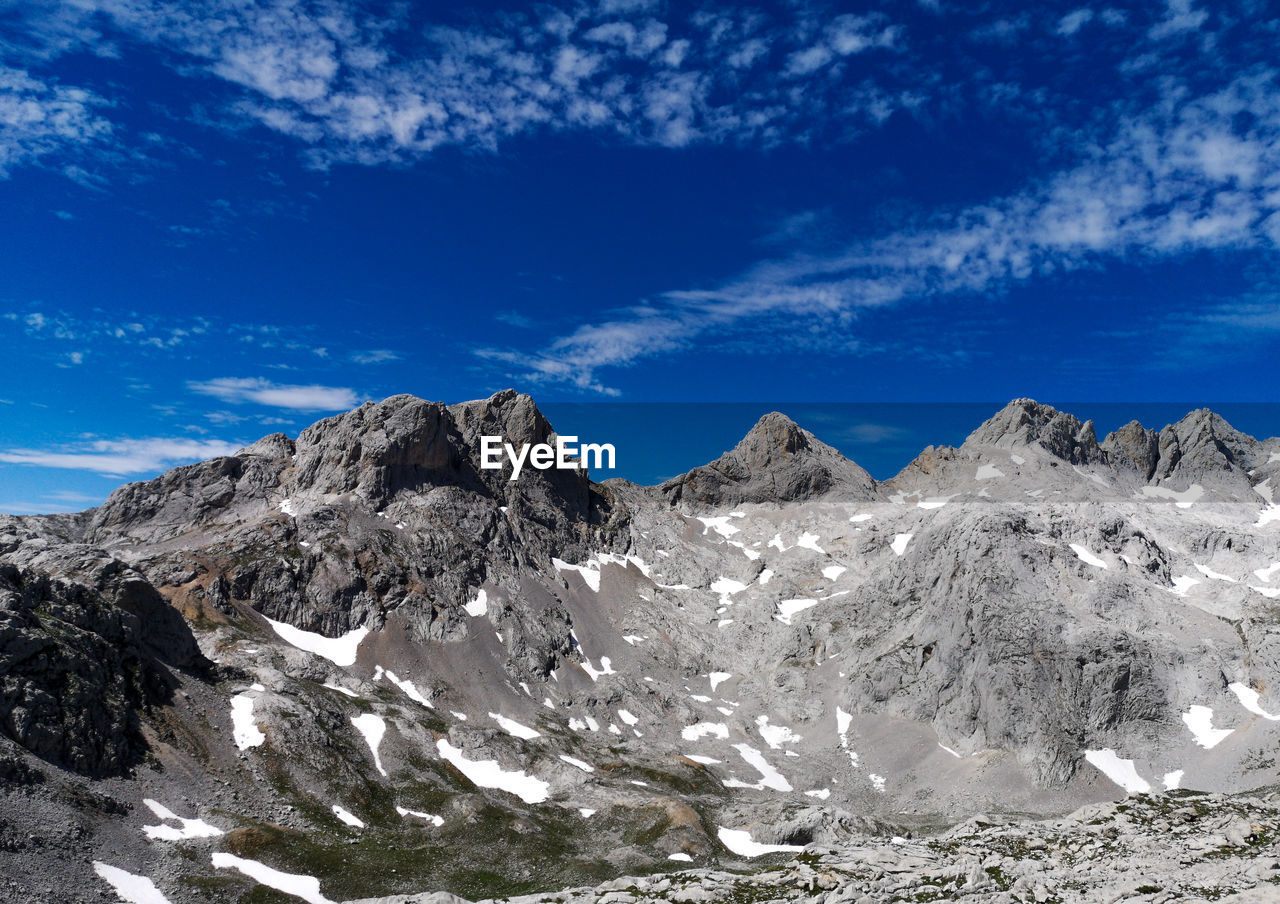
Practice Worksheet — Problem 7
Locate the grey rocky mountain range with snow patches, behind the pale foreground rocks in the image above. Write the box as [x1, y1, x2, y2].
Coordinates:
[0, 392, 1280, 904]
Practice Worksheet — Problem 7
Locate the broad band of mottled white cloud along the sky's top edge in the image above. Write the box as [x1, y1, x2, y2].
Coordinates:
[2, 0, 921, 174]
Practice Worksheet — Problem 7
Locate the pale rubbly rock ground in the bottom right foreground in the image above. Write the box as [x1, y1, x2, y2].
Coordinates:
[358, 791, 1280, 904]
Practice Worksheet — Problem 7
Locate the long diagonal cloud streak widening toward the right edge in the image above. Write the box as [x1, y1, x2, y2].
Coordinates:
[479, 51, 1280, 393]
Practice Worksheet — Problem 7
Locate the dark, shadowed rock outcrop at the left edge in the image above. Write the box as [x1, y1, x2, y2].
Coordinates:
[0, 522, 206, 776]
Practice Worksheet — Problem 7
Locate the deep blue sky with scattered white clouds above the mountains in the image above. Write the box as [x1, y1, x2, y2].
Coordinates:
[0, 0, 1280, 512]
